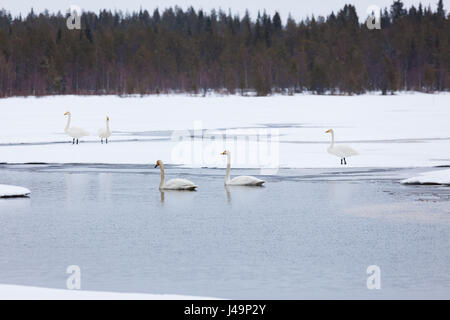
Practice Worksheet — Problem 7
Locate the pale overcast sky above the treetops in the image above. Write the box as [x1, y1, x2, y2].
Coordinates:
[0, 0, 442, 20]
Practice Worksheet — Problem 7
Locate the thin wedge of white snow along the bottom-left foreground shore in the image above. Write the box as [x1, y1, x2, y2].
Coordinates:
[0, 284, 215, 300]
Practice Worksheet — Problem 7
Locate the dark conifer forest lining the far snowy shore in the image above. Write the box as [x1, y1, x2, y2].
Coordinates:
[0, 0, 450, 97]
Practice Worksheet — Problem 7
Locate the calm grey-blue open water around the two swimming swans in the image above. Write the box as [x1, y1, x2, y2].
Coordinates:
[0, 164, 450, 299]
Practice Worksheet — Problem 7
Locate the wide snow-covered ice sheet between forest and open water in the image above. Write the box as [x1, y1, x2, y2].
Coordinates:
[0, 93, 450, 168]
